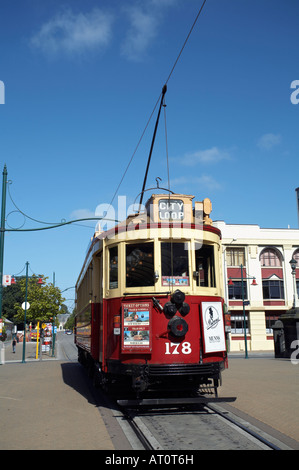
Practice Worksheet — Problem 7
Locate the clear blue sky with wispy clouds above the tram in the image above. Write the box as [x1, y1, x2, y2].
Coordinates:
[0, 0, 299, 312]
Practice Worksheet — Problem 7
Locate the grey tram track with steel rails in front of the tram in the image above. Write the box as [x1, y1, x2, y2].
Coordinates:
[116, 404, 286, 451]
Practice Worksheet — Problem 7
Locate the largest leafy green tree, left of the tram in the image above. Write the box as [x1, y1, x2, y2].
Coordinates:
[13, 275, 65, 323]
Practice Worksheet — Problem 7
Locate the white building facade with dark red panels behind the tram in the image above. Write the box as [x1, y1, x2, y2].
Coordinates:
[213, 221, 299, 351]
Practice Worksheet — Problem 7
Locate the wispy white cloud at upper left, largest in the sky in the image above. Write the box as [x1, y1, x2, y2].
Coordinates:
[31, 8, 113, 56]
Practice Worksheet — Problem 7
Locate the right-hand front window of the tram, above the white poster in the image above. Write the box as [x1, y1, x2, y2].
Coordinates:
[195, 245, 216, 287]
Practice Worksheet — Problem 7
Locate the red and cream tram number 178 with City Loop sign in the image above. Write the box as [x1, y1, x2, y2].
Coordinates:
[75, 194, 227, 395]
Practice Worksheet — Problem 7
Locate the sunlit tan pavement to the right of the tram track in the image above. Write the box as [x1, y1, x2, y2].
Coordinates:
[219, 353, 299, 449]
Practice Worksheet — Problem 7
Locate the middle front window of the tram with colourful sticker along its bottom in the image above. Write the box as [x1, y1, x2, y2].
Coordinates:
[161, 243, 189, 286]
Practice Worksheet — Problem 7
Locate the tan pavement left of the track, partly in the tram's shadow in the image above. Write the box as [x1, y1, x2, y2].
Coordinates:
[0, 360, 116, 450]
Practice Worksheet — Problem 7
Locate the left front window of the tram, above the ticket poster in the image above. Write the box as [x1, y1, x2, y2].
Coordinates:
[126, 243, 154, 287]
